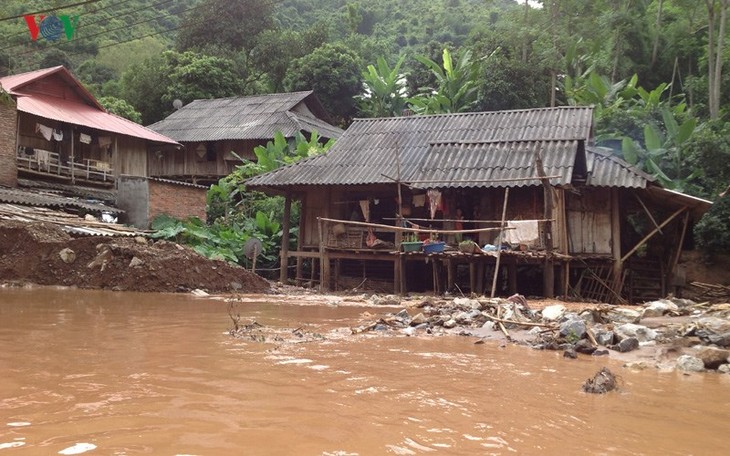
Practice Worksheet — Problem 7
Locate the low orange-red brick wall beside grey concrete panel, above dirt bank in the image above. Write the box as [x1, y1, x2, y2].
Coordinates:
[148, 179, 208, 222]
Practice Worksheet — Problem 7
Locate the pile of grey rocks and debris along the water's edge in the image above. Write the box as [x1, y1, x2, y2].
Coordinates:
[352, 295, 730, 373]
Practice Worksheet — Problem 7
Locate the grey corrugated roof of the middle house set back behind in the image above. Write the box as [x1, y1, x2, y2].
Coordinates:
[149, 91, 342, 142]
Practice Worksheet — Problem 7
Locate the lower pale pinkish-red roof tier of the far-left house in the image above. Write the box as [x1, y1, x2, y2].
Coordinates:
[17, 94, 178, 145]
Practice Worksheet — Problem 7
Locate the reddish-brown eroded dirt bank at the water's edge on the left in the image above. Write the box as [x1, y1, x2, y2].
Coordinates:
[0, 221, 270, 293]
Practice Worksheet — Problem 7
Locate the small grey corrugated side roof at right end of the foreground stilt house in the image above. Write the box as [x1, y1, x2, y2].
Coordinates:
[586, 147, 655, 188]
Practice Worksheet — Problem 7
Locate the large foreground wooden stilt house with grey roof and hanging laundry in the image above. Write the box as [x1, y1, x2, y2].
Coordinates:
[247, 107, 711, 302]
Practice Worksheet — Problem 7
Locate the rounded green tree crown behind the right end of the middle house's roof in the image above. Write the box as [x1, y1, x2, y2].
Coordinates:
[284, 44, 362, 123]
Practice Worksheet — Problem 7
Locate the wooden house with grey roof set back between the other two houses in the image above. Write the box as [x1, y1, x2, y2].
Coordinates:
[149, 90, 342, 184]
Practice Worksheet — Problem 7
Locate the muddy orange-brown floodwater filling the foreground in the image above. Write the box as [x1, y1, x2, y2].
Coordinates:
[0, 288, 730, 455]
